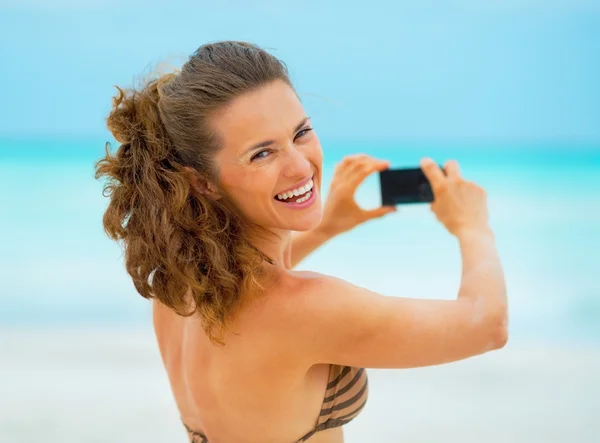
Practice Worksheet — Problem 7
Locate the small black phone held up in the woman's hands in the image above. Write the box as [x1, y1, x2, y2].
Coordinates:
[379, 166, 445, 206]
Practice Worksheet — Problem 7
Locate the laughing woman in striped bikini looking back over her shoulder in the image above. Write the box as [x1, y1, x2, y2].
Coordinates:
[96, 41, 507, 443]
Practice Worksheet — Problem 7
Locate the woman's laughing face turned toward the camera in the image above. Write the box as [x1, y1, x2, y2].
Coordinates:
[213, 81, 323, 231]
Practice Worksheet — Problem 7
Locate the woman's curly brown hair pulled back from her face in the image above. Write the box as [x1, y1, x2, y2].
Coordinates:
[94, 41, 292, 345]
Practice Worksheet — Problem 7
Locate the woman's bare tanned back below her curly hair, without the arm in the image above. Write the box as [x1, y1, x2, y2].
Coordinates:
[153, 272, 343, 443]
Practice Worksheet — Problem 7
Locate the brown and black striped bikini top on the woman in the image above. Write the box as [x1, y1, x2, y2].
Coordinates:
[184, 365, 369, 443]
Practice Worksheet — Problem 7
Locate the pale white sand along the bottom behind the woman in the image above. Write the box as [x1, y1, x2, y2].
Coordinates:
[0, 328, 600, 443]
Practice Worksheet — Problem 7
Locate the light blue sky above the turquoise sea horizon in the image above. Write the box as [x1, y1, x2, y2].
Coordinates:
[0, 0, 600, 143]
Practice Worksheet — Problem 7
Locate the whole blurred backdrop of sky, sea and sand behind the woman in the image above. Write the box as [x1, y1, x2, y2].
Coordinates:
[0, 0, 600, 443]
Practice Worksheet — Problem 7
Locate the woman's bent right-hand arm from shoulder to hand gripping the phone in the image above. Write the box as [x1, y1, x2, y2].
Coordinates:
[280, 160, 508, 368]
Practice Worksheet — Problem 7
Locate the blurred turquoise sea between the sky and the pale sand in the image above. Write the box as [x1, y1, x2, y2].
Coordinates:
[0, 138, 600, 342]
